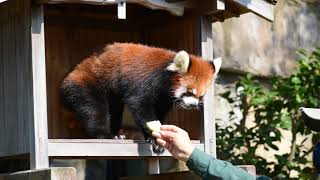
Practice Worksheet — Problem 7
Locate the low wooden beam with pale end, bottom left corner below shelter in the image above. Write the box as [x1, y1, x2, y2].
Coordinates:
[0, 167, 77, 180]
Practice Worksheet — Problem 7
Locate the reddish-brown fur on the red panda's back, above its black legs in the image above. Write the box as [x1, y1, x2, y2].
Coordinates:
[63, 43, 175, 85]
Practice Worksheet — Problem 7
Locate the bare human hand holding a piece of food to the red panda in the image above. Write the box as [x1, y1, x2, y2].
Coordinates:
[152, 125, 194, 162]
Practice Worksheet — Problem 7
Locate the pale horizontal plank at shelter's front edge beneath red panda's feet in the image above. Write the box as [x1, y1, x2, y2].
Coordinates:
[48, 139, 204, 159]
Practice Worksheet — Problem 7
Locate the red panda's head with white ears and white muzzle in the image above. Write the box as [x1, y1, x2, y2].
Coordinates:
[167, 51, 221, 108]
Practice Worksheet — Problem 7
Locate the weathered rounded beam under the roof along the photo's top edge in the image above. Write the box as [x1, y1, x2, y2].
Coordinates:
[36, 0, 189, 16]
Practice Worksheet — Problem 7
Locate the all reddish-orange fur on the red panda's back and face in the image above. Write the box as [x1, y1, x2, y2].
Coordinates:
[63, 43, 214, 93]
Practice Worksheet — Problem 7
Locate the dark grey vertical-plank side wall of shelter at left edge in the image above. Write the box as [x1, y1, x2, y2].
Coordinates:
[0, 0, 32, 156]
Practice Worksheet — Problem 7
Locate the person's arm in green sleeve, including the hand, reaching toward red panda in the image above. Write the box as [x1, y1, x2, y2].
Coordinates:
[152, 125, 270, 180]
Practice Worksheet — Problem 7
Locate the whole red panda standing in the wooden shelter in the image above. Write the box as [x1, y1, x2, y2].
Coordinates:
[61, 43, 221, 150]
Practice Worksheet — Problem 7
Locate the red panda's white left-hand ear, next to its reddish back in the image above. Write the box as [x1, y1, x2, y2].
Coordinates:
[167, 51, 190, 74]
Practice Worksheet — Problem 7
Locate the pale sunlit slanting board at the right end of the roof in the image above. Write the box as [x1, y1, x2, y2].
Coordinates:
[234, 0, 274, 21]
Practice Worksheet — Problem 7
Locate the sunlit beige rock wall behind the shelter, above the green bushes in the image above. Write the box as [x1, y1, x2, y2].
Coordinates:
[213, 0, 320, 76]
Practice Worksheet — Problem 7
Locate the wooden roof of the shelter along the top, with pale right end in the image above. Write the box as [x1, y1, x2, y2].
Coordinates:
[34, 0, 276, 21]
